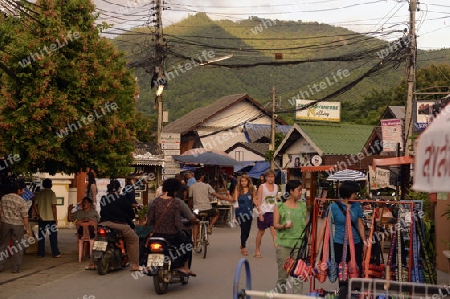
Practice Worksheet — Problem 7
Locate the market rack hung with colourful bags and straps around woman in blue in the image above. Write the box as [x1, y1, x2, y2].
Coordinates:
[304, 198, 436, 290]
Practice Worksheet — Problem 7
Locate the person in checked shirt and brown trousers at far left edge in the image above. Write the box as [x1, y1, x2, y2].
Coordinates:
[0, 180, 31, 273]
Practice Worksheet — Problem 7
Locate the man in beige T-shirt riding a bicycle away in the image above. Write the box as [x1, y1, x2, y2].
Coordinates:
[189, 170, 229, 249]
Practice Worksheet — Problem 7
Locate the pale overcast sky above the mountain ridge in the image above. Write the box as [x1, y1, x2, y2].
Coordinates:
[95, 0, 450, 49]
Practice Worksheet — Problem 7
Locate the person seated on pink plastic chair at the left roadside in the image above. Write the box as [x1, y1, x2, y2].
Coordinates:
[67, 196, 100, 270]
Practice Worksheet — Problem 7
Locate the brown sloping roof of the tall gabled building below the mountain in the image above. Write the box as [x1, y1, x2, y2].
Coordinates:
[163, 93, 284, 134]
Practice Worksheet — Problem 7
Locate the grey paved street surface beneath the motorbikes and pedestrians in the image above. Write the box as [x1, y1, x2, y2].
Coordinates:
[0, 220, 292, 299]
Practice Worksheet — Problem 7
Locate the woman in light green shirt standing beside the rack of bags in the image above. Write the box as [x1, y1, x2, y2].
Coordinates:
[273, 180, 306, 294]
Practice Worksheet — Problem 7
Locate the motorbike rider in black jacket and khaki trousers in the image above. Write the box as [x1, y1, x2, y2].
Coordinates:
[99, 180, 140, 271]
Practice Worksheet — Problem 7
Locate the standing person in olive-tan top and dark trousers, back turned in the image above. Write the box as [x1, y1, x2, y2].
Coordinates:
[33, 179, 64, 258]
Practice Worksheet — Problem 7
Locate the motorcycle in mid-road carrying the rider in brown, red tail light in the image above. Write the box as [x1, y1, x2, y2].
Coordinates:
[146, 223, 192, 295]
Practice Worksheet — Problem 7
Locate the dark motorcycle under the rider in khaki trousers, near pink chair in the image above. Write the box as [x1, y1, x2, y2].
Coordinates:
[92, 225, 128, 275]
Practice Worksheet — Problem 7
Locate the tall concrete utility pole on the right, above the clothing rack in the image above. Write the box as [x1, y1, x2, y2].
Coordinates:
[403, 0, 417, 156]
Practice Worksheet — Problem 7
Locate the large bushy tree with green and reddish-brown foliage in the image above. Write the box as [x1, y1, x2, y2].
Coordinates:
[0, 0, 137, 175]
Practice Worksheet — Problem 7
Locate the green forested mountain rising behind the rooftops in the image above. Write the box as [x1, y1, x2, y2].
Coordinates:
[111, 13, 450, 122]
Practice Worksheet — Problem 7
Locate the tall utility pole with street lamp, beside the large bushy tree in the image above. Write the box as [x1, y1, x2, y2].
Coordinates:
[155, 0, 165, 149]
